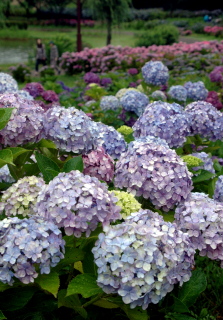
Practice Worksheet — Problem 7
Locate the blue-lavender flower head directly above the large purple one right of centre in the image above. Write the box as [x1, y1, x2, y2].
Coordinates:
[133, 101, 190, 147]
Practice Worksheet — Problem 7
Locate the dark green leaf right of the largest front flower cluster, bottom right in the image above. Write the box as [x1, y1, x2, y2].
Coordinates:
[178, 270, 207, 308]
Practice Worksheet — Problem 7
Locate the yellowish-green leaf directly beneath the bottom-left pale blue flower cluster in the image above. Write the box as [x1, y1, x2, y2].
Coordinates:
[35, 272, 60, 298]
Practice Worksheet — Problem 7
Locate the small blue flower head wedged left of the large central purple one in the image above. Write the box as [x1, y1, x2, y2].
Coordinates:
[92, 122, 127, 160]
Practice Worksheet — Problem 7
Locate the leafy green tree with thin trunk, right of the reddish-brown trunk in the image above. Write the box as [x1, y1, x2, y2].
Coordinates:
[89, 0, 131, 45]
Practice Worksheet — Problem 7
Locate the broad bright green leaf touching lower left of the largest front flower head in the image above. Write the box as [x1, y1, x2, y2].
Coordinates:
[67, 273, 103, 298]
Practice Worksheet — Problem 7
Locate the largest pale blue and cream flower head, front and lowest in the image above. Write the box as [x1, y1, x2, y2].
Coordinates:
[92, 210, 194, 309]
